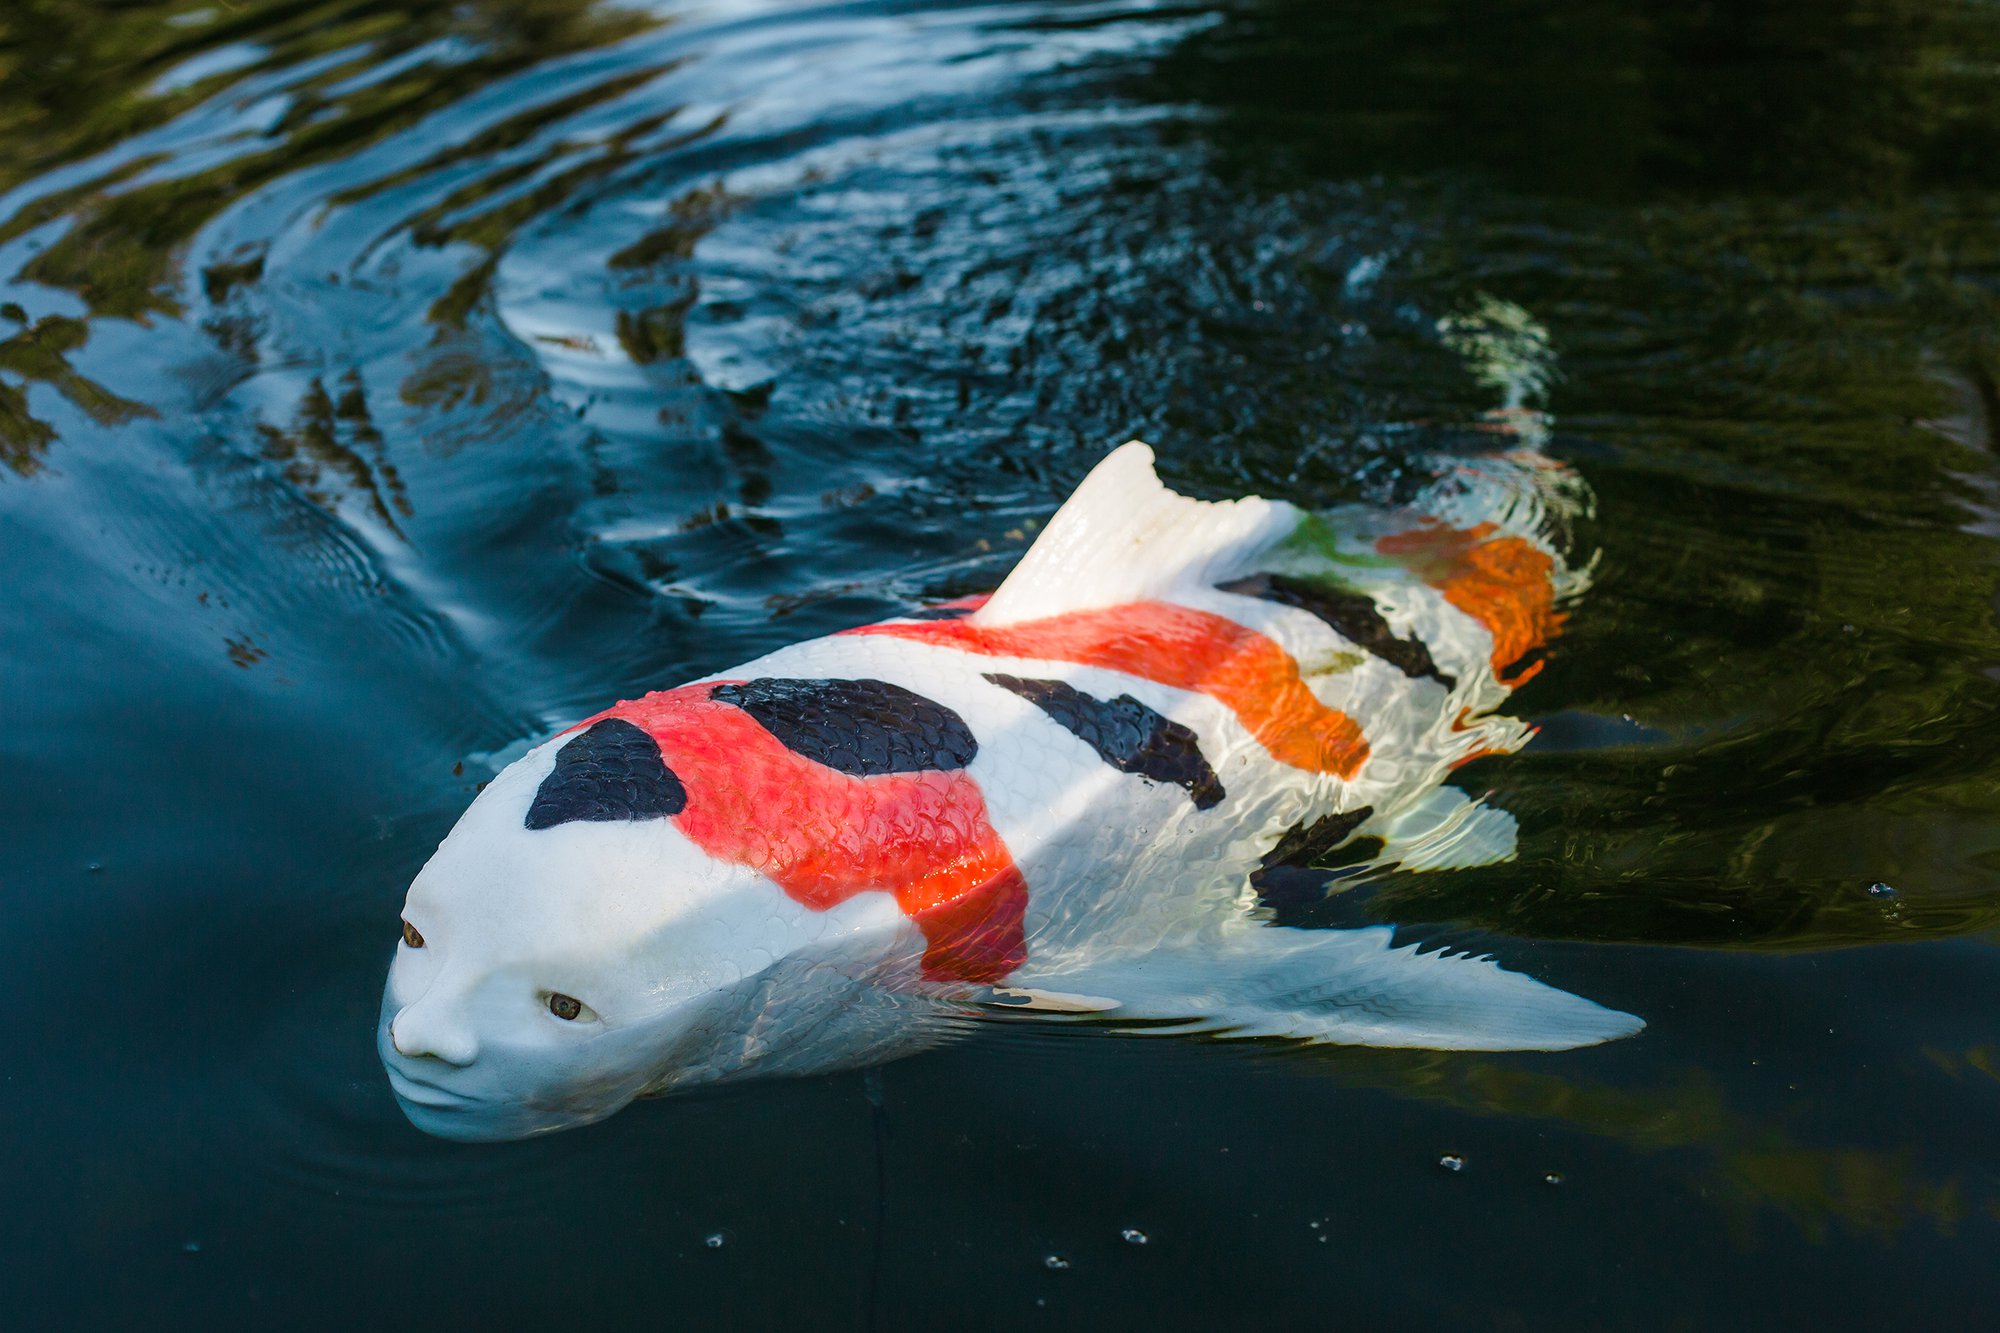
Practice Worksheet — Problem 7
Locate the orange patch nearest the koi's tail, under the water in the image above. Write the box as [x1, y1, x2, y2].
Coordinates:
[1376, 520, 1564, 689]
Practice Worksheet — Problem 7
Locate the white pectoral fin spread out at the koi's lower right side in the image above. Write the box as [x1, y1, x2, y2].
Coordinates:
[1012, 923, 1646, 1051]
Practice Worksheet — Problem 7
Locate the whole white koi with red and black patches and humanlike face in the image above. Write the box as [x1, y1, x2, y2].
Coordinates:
[380, 444, 1640, 1139]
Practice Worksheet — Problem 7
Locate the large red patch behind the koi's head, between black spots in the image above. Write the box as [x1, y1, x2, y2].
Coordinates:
[580, 681, 1028, 985]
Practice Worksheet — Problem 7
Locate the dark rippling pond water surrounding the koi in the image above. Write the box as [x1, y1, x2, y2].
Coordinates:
[11, 0, 2000, 1329]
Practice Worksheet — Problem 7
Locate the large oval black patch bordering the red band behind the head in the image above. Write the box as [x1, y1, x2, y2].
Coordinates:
[708, 677, 980, 777]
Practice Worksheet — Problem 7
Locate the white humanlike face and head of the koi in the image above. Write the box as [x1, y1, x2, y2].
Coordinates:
[376, 743, 896, 1141]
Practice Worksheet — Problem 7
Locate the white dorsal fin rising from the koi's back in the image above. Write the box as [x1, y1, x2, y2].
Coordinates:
[970, 440, 1300, 624]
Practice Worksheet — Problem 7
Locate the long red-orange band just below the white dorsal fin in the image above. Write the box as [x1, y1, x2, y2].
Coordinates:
[846, 602, 1368, 779]
